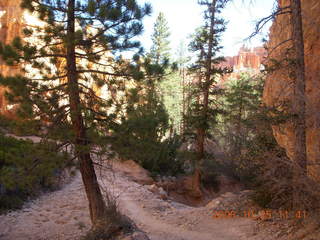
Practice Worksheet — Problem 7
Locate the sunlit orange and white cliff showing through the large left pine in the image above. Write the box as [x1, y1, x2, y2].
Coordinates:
[0, 0, 111, 116]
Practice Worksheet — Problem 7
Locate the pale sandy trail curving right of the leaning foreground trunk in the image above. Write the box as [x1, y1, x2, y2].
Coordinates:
[101, 165, 253, 240]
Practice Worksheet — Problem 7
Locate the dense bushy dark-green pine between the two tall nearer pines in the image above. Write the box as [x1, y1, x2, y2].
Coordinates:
[109, 60, 169, 172]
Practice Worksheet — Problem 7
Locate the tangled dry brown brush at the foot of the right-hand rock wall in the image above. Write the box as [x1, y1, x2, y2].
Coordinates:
[261, 156, 320, 213]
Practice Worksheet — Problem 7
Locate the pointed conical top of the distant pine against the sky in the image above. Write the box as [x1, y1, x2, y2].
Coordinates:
[150, 12, 170, 64]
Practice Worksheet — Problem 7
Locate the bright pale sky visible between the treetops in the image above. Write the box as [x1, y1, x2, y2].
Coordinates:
[138, 0, 274, 56]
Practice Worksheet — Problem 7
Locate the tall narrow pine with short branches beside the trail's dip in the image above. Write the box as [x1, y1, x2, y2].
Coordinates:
[189, 0, 227, 197]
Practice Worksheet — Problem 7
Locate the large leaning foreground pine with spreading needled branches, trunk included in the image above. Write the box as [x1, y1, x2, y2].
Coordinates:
[0, 0, 151, 227]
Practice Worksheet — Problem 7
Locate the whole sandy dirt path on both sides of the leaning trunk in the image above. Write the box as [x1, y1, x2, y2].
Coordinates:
[0, 158, 253, 240]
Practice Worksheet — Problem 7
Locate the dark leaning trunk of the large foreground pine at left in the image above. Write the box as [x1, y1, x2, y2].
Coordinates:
[67, 0, 105, 227]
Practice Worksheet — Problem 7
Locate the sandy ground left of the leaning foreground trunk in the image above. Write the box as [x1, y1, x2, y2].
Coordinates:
[0, 174, 90, 240]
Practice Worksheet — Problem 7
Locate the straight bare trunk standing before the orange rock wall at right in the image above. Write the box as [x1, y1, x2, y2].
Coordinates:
[291, 0, 307, 170]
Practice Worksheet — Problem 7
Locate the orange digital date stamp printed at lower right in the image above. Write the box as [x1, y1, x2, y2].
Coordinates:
[212, 209, 307, 219]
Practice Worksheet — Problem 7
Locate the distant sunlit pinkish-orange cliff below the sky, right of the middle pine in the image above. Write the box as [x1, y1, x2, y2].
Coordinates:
[219, 47, 266, 86]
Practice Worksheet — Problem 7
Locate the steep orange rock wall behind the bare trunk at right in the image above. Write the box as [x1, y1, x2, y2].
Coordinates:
[263, 0, 320, 180]
